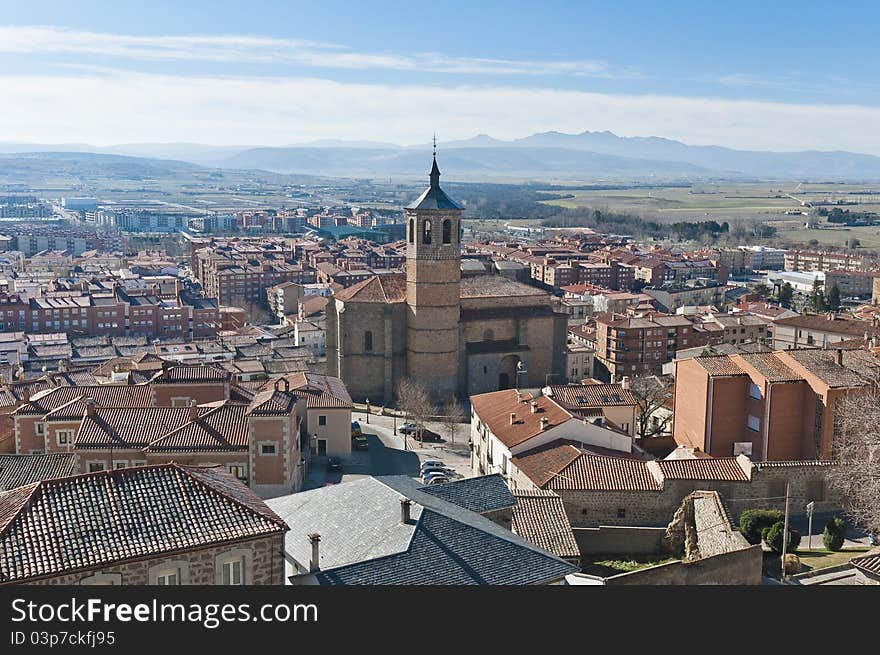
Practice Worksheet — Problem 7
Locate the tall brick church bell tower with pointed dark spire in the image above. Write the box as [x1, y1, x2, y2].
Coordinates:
[406, 139, 463, 397]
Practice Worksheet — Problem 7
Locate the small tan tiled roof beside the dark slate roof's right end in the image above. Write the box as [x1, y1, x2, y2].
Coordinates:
[512, 492, 581, 558]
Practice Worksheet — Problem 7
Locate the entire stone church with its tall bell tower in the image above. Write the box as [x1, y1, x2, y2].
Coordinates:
[327, 153, 566, 403]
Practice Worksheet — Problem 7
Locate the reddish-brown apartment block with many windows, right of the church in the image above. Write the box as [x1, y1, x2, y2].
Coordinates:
[596, 314, 704, 382]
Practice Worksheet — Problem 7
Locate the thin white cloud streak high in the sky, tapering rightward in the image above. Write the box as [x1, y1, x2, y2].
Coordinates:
[0, 25, 637, 78]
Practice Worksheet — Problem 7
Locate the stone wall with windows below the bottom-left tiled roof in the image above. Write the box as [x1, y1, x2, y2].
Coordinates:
[27, 533, 284, 585]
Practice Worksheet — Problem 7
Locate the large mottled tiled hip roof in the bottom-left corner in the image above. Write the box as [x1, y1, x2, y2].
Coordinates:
[0, 464, 287, 582]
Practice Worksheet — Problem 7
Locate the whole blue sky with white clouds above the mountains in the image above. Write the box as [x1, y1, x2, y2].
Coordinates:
[0, 0, 880, 155]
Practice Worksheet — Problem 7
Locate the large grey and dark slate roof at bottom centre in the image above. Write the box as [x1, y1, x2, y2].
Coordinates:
[267, 476, 577, 585]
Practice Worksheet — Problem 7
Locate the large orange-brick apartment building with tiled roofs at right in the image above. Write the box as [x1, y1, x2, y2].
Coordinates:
[673, 349, 880, 461]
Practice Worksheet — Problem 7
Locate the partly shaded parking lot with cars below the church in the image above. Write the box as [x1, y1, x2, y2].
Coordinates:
[304, 412, 474, 489]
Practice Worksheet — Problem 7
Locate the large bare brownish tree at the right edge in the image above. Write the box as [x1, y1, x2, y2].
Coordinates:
[828, 384, 880, 532]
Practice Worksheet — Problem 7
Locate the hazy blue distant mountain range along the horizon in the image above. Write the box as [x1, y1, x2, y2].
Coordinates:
[0, 131, 880, 181]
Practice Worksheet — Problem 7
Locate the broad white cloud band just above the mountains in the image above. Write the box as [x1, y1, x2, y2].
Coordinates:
[0, 72, 880, 155]
